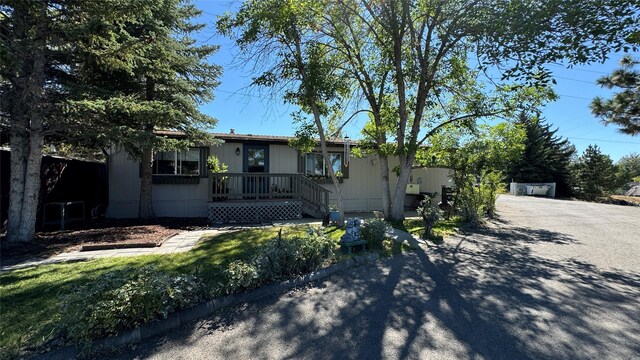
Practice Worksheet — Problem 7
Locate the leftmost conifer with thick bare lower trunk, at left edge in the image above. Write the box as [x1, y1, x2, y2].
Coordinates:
[0, 0, 132, 242]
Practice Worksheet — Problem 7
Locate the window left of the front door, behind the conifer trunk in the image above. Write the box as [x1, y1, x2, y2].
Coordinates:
[153, 148, 200, 176]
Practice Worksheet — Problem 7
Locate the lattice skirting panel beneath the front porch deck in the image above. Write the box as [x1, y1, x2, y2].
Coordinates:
[208, 200, 302, 224]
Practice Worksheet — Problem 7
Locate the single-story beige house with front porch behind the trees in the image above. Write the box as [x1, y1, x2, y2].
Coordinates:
[107, 132, 450, 222]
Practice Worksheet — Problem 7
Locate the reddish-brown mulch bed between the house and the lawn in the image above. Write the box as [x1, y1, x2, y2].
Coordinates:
[0, 218, 207, 265]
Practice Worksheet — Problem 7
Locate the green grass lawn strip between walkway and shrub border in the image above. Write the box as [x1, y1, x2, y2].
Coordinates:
[0, 227, 306, 357]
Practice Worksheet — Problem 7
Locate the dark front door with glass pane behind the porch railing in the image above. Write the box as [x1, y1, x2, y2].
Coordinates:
[242, 144, 269, 197]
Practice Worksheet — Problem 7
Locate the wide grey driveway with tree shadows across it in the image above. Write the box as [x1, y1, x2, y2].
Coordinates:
[102, 196, 640, 359]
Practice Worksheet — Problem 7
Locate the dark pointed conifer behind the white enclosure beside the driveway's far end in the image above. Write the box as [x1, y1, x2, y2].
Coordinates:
[506, 114, 576, 197]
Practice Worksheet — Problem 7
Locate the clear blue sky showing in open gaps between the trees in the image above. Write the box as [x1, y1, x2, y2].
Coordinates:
[195, 0, 640, 161]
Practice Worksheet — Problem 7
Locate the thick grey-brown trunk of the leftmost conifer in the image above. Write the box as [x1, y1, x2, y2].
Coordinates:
[7, 2, 46, 242]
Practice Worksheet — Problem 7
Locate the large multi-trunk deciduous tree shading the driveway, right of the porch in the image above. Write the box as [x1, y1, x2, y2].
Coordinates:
[325, 0, 638, 220]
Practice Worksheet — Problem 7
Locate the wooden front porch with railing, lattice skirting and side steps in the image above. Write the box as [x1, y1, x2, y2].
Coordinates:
[208, 173, 330, 224]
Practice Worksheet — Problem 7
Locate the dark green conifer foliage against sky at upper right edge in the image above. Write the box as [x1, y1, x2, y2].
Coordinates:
[591, 56, 640, 135]
